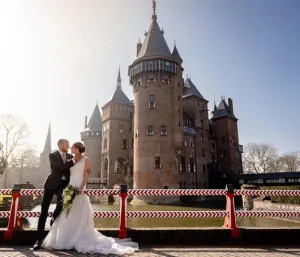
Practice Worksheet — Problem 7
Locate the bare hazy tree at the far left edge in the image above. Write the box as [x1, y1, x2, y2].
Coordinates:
[0, 115, 28, 188]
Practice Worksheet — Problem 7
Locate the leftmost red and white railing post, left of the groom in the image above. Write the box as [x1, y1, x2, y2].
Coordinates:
[4, 185, 22, 240]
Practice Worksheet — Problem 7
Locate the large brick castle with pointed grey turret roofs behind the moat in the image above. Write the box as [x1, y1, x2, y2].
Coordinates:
[81, 1, 243, 202]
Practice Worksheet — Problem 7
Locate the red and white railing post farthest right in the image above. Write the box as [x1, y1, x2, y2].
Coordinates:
[223, 185, 240, 238]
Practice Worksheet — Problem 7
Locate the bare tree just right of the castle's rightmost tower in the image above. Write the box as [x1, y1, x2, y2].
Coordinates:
[243, 143, 279, 173]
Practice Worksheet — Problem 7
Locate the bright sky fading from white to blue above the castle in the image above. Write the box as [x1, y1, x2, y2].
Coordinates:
[0, 0, 300, 153]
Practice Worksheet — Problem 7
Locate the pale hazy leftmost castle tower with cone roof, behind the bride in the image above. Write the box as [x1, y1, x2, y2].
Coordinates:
[80, 103, 102, 188]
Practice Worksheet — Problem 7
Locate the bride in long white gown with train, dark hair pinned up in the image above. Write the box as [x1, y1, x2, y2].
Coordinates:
[42, 142, 138, 255]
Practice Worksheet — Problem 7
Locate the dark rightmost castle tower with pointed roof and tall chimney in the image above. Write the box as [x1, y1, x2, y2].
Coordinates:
[212, 97, 243, 174]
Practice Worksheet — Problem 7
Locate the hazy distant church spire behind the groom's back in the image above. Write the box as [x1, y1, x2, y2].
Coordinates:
[39, 122, 52, 185]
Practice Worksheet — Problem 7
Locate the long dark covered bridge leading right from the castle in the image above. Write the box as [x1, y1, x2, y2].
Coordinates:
[239, 172, 300, 186]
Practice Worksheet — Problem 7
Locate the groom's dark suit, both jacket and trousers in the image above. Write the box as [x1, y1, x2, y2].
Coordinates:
[38, 151, 74, 244]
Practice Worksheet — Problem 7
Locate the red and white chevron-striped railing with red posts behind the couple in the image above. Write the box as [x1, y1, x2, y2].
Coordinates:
[0, 185, 300, 240]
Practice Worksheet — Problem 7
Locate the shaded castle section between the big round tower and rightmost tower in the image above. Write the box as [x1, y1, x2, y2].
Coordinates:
[180, 77, 211, 188]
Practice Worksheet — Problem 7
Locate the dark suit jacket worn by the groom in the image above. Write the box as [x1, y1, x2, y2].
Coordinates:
[44, 151, 74, 190]
